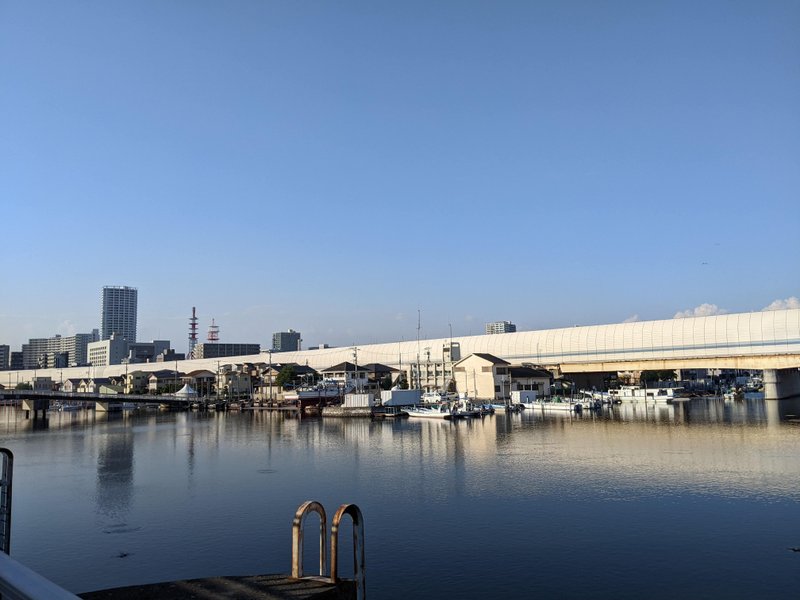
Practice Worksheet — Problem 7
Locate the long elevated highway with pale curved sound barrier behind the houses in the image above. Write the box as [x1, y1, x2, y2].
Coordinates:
[0, 309, 800, 398]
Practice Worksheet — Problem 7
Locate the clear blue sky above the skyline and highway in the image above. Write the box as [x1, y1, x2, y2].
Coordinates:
[0, 0, 800, 351]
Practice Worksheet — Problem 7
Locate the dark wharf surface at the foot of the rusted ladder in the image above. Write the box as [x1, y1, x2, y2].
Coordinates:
[78, 575, 356, 600]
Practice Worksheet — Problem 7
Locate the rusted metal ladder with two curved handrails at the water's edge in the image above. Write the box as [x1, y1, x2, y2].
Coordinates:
[292, 500, 366, 600]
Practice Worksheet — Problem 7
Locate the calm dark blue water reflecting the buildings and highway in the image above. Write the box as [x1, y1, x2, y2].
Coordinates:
[0, 400, 800, 598]
